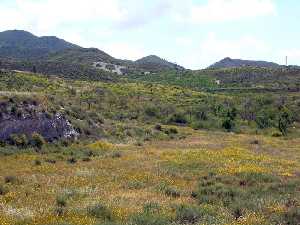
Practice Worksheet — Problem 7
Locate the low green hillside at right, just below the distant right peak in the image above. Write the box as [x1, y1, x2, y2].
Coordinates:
[128, 66, 300, 92]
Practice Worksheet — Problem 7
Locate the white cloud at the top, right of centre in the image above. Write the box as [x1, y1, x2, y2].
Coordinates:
[176, 0, 276, 24]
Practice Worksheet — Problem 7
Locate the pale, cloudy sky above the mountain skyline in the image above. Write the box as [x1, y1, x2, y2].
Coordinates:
[0, 0, 300, 69]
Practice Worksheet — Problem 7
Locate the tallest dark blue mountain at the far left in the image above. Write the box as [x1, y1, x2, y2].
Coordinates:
[0, 30, 79, 59]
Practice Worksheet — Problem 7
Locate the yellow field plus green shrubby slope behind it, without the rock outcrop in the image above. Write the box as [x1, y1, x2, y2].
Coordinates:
[0, 71, 300, 225]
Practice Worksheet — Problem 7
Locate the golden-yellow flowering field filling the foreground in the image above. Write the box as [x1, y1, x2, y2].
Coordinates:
[0, 128, 300, 225]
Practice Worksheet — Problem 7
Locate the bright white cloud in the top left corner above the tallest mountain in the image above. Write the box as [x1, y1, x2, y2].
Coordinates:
[0, 0, 125, 33]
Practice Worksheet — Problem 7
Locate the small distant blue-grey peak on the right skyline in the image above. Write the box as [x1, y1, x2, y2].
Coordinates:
[208, 57, 281, 69]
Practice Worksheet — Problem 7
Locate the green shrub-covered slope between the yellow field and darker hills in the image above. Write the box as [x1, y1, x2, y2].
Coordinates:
[0, 72, 300, 142]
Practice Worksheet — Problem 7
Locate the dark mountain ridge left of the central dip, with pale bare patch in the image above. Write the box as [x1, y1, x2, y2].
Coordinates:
[0, 30, 184, 74]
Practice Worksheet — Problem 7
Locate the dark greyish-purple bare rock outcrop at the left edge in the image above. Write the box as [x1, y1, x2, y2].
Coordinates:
[0, 101, 78, 142]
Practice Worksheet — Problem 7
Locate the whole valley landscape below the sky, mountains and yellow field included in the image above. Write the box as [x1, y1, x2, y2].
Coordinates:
[0, 31, 300, 225]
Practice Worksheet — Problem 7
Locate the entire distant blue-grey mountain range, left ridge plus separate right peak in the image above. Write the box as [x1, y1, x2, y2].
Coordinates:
[0, 30, 299, 78]
